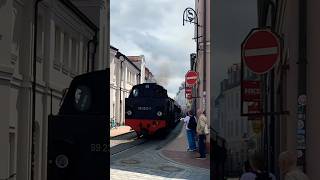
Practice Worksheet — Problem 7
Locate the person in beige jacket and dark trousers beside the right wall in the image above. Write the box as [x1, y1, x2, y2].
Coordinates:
[197, 109, 209, 159]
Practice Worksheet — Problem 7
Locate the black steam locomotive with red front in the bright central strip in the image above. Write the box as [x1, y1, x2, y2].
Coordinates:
[125, 83, 181, 137]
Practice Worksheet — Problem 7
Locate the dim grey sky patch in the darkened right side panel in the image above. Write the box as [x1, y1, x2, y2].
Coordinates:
[211, 0, 258, 97]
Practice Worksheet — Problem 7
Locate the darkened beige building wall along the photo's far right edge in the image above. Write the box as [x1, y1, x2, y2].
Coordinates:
[260, 0, 320, 179]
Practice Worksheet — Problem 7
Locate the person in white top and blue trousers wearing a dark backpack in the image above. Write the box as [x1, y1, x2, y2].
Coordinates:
[184, 111, 196, 151]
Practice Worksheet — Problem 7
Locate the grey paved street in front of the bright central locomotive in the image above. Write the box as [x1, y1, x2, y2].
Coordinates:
[110, 122, 210, 180]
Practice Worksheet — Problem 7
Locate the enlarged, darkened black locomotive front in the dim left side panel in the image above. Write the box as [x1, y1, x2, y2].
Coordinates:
[47, 70, 110, 180]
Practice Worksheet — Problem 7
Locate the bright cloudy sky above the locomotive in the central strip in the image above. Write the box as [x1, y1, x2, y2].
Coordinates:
[110, 0, 195, 98]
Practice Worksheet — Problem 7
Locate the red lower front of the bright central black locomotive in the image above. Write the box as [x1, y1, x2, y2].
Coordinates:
[125, 119, 167, 135]
